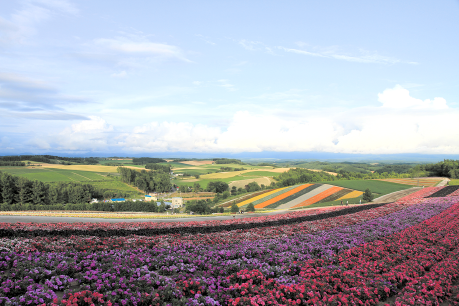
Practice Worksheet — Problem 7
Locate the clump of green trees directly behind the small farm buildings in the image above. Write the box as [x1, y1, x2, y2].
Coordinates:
[117, 167, 172, 193]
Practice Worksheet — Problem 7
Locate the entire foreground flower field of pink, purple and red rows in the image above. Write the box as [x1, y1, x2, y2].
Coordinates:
[0, 186, 459, 306]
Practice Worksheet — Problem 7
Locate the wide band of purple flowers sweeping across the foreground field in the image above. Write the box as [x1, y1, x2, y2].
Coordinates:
[0, 199, 457, 305]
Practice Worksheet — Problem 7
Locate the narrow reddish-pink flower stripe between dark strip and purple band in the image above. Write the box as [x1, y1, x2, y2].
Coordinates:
[0, 203, 416, 253]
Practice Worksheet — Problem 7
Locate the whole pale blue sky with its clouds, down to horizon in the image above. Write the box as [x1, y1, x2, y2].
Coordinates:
[0, 0, 459, 156]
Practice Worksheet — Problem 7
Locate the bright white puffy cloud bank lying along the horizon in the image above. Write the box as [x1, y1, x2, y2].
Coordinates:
[47, 85, 459, 154]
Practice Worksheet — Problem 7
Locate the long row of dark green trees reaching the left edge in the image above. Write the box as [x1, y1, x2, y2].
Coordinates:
[0, 172, 116, 206]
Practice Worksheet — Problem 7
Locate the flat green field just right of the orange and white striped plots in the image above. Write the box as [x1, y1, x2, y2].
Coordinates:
[321, 180, 413, 195]
